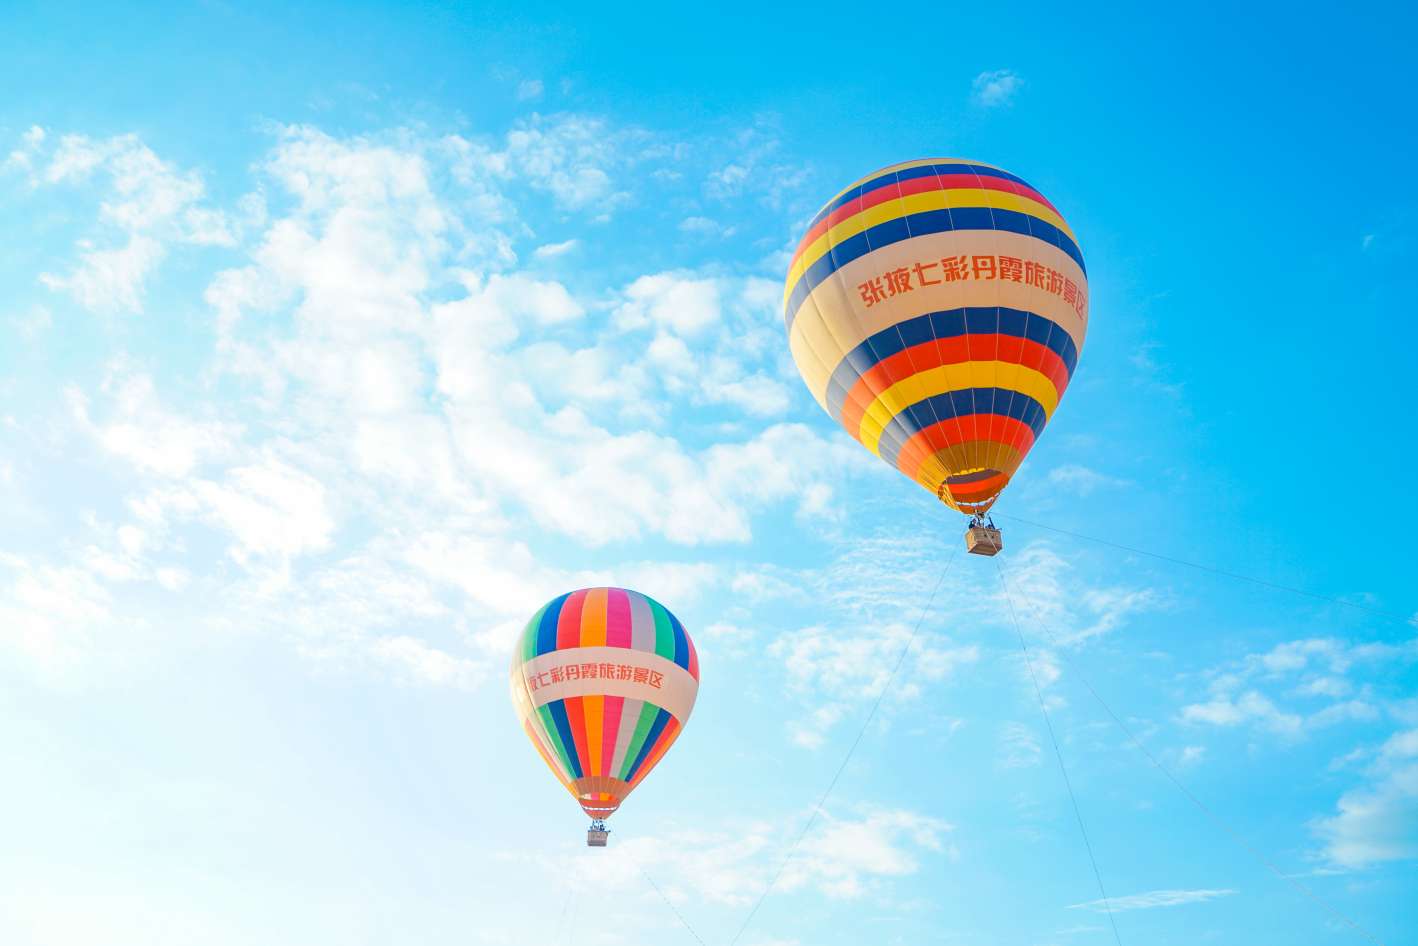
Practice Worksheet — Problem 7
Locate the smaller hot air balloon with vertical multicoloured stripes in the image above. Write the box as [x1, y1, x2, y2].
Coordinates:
[512, 587, 699, 847]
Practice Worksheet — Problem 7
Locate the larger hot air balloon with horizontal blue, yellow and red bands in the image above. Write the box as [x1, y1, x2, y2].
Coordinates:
[783, 159, 1088, 555]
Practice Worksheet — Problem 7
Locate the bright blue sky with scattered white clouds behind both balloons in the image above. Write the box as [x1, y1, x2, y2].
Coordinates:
[0, 1, 1418, 946]
